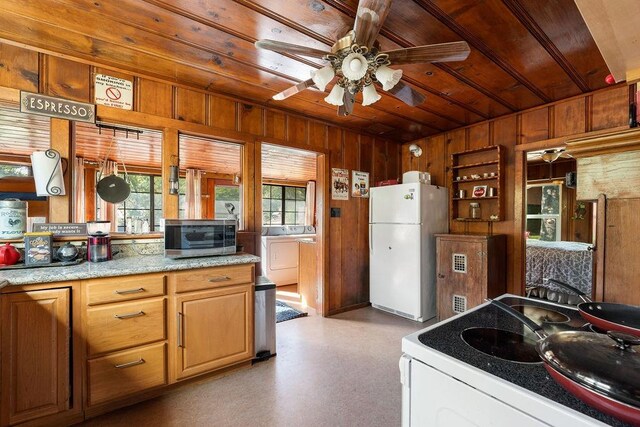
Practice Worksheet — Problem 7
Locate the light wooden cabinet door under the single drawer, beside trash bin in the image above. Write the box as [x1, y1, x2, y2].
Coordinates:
[173, 284, 253, 379]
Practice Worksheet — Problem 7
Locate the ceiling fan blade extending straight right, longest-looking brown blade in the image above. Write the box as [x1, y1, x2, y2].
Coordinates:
[384, 41, 471, 65]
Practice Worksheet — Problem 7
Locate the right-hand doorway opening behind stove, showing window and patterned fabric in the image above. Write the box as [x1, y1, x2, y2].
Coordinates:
[522, 147, 596, 304]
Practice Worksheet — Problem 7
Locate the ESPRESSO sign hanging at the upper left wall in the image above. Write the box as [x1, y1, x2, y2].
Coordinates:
[20, 91, 96, 123]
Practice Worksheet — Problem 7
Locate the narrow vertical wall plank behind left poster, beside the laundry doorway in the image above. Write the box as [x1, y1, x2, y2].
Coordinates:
[325, 126, 349, 313]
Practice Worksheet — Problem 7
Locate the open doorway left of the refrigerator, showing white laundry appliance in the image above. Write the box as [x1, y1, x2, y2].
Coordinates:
[259, 144, 324, 314]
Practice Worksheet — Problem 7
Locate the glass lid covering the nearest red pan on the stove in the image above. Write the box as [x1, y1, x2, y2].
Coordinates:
[537, 331, 640, 408]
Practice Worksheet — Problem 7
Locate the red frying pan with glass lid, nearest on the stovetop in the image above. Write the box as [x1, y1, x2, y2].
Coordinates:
[491, 300, 640, 426]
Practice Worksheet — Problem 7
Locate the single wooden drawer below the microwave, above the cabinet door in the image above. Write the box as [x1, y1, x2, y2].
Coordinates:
[173, 265, 253, 293]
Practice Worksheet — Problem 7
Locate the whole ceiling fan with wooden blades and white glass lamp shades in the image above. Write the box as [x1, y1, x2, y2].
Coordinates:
[255, 0, 470, 116]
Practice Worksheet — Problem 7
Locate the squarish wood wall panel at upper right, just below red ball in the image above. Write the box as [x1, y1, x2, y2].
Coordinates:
[587, 85, 630, 131]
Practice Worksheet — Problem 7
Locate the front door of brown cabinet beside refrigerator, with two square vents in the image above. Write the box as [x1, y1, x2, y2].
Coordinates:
[436, 239, 486, 320]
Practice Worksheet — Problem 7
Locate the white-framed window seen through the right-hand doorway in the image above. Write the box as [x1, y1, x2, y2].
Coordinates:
[527, 184, 562, 241]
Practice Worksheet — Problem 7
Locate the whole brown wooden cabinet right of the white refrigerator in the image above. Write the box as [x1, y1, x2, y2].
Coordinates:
[436, 234, 506, 320]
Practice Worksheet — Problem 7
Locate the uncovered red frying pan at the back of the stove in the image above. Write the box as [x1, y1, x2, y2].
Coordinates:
[549, 279, 640, 337]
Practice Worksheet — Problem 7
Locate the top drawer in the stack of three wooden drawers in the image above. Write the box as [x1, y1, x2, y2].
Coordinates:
[84, 274, 166, 305]
